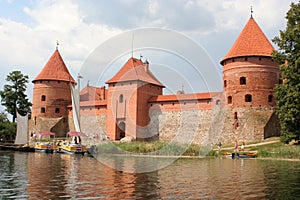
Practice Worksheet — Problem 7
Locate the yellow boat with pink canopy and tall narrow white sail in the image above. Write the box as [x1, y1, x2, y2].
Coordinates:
[59, 80, 87, 154]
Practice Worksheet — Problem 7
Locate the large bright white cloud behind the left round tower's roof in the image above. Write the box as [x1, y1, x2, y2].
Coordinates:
[0, 0, 121, 109]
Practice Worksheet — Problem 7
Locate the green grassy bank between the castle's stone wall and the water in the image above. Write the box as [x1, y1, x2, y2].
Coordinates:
[97, 141, 300, 159]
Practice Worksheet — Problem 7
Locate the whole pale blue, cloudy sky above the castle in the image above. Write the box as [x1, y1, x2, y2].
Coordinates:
[0, 0, 297, 113]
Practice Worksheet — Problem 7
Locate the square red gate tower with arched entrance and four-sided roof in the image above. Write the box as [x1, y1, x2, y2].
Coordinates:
[106, 58, 164, 140]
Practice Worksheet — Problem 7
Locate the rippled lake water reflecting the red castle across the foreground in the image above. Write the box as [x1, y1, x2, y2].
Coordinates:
[0, 151, 300, 199]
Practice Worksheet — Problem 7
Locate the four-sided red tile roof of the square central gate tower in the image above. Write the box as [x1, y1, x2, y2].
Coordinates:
[106, 58, 164, 87]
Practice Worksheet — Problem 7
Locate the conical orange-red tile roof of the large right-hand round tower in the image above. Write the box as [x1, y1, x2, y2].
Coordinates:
[221, 17, 274, 65]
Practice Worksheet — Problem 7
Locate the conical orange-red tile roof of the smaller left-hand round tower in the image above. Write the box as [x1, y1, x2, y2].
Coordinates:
[32, 50, 75, 83]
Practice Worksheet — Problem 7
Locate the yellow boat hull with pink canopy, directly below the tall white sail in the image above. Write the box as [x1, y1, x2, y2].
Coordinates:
[59, 132, 87, 155]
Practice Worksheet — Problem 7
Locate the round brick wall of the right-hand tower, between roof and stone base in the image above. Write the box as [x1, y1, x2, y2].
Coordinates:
[223, 56, 280, 108]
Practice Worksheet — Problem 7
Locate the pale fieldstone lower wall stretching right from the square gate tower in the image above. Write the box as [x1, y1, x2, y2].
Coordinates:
[149, 106, 279, 145]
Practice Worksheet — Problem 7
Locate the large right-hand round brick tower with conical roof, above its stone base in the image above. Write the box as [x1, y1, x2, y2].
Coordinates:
[221, 15, 280, 108]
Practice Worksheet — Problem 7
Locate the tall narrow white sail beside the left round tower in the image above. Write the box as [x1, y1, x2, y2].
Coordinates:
[70, 84, 81, 132]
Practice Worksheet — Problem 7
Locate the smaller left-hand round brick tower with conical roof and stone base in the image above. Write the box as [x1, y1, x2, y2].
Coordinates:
[31, 49, 75, 136]
